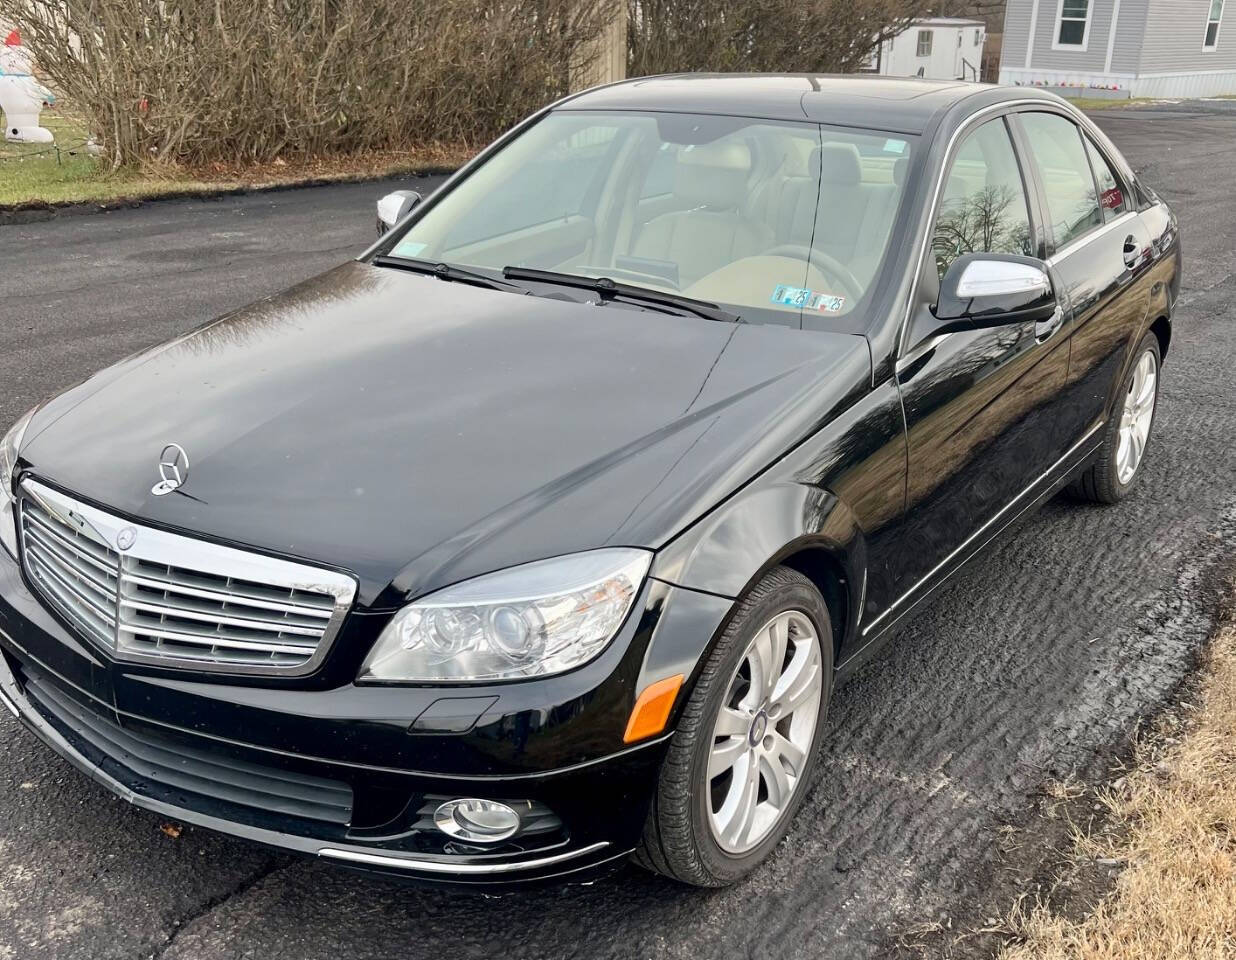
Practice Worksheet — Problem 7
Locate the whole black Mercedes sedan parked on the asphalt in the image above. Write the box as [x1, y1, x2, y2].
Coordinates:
[0, 75, 1180, 886]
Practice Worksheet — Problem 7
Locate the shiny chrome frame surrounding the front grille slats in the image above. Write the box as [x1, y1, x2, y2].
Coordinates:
[15, 477, 358, 677]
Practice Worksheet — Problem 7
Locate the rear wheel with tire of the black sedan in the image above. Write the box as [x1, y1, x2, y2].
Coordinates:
[1069, 334, 1162, 503]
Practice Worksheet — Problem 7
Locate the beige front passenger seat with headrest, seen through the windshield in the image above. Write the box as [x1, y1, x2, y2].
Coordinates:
[630, 142, 773, 288]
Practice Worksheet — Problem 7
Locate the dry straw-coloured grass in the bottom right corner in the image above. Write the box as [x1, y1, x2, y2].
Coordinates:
[1000, 607, 1236, 960]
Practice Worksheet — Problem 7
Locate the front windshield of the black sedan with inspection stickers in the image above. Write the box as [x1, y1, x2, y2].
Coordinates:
[389, 111, 913, 325]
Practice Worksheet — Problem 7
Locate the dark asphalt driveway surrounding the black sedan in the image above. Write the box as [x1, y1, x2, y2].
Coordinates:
[0, 105, 1236, 960]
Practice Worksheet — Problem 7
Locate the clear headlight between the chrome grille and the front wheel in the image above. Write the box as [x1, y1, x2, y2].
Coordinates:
[360, 547, 653, 683]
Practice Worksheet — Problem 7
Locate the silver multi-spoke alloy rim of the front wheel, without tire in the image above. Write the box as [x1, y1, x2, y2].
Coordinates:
[707, 610, 824, 855]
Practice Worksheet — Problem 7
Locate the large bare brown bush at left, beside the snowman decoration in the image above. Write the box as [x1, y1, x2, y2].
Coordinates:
[0, 0, 604, 164]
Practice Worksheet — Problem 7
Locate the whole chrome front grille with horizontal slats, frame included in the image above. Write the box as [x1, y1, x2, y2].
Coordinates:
[20, 481, 356, 675]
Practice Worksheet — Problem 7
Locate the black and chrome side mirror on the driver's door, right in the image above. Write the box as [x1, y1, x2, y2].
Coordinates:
[932, 253, 1057, 334]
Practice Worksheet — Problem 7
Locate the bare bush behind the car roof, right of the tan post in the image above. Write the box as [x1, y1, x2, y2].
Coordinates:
[627, 0, 928, 75]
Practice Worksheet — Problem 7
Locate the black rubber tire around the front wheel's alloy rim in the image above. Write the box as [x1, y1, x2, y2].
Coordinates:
[690, 578, 833, 883]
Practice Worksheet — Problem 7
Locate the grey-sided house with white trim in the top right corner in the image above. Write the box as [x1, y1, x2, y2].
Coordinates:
[1000, 0, 1236, 96]
